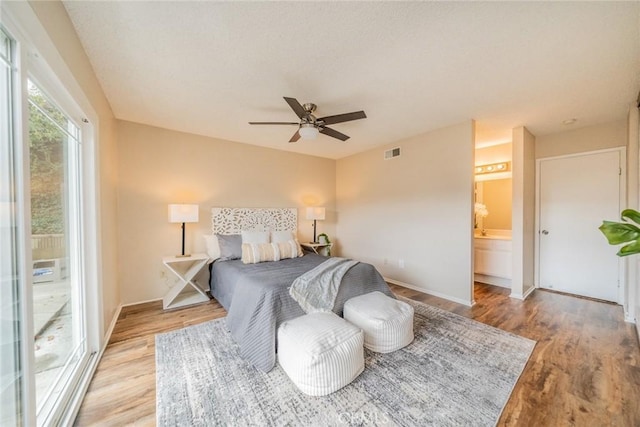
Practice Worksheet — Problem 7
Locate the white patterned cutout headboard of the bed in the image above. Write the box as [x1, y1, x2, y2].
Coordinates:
[211, 208, 298, 234]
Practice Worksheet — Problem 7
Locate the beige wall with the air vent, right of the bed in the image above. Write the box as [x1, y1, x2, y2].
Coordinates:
[336, 121, 474, 304]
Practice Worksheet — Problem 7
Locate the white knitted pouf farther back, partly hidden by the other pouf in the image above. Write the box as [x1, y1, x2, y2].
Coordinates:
[343, 291, 413, 353]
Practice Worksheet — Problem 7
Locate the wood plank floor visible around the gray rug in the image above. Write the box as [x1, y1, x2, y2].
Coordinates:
[76, 284, 640, 427]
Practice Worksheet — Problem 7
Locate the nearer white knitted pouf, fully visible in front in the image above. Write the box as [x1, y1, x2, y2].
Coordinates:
[278, 312, 364, 396]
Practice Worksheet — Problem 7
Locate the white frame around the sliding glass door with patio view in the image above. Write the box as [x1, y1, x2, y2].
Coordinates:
[0, 2, 106, 425]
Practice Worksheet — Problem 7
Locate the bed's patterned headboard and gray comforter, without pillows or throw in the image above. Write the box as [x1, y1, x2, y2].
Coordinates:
[210, 208, 393, 372]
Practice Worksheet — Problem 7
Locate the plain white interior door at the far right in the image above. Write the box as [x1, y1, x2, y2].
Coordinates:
[538, 150, 622, 302]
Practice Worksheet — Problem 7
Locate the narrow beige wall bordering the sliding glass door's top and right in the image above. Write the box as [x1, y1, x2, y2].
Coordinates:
[29, 1, 120, 342]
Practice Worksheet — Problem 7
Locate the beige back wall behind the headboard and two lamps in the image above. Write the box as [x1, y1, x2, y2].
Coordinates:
[118, 121, 339, 303]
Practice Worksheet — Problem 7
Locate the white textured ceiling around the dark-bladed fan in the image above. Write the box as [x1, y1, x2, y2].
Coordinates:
[64, 1, 640, 159]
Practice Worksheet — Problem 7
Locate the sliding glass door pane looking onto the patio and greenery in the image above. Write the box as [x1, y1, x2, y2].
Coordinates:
[27, 80, 87, 424]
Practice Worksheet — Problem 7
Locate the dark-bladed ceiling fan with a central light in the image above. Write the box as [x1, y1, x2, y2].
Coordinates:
[249, 96, 367, 142]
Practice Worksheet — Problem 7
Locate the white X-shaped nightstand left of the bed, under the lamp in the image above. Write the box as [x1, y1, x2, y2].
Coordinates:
[162, 254, 209, 310]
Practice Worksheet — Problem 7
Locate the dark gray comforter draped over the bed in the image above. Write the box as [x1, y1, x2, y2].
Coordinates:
[210, 254, 393, 372]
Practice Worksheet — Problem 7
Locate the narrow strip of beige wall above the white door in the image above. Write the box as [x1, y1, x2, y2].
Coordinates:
[535, 120, 627, 159]
